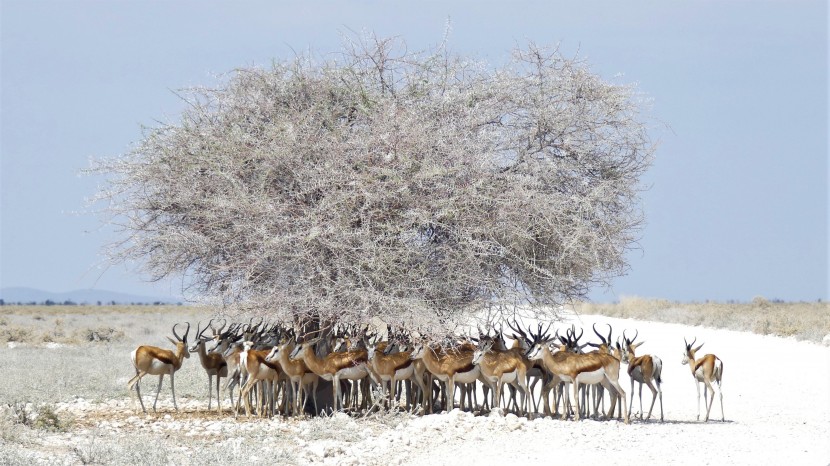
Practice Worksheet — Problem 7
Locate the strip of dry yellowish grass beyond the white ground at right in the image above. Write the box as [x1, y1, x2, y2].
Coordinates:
[575, 297, 830, 342]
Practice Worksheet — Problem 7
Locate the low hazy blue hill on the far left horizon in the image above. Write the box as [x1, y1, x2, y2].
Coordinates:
[0, 287, 182, 304]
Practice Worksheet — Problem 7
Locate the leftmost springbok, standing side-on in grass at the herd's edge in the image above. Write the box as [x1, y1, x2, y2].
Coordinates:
[127, 322, 190, 413]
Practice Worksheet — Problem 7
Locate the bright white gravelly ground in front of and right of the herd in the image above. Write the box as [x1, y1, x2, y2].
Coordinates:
[3, 316, 830, 466]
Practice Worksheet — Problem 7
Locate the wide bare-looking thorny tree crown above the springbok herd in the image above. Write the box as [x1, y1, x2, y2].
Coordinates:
[93, 38, 653, 333]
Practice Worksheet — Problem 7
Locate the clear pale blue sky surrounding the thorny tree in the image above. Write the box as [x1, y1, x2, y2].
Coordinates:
[0, 0, 828, 301]
